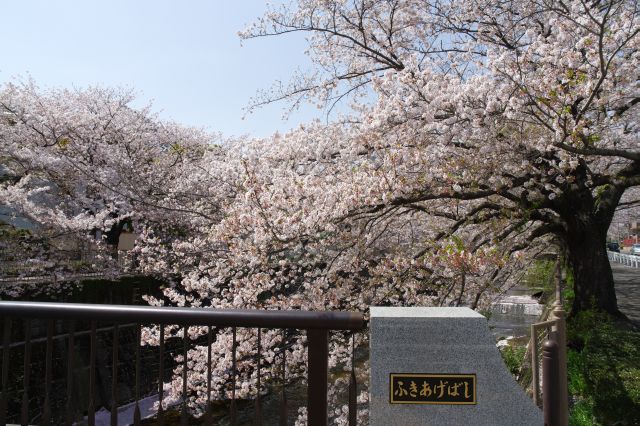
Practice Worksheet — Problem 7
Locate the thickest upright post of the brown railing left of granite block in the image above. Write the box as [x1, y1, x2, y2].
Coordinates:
[307, 329, 329, 426]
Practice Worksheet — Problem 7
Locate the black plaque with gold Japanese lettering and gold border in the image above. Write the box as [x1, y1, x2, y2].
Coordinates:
[389, 373, 476, 405]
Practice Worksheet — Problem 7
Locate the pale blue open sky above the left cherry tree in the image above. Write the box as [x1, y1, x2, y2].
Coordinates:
[0, 0, 322, 136]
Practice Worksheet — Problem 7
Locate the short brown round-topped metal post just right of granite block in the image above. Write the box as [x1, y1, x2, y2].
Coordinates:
[542, 339, 561, 426]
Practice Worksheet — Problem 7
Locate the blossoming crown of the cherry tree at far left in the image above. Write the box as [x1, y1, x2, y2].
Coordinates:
[0, 82, 224, 264]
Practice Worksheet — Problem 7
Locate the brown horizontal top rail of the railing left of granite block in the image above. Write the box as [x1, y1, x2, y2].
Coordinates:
[0, 301, 365, 330]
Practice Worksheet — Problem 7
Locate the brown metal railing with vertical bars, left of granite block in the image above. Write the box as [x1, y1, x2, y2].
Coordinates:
[0, 302, 365, 426]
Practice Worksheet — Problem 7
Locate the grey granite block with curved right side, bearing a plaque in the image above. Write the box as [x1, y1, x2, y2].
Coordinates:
[369, 307, 543, 426]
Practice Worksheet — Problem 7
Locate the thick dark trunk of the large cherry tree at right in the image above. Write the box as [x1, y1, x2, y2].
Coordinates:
[565, 215, 621, 316]
